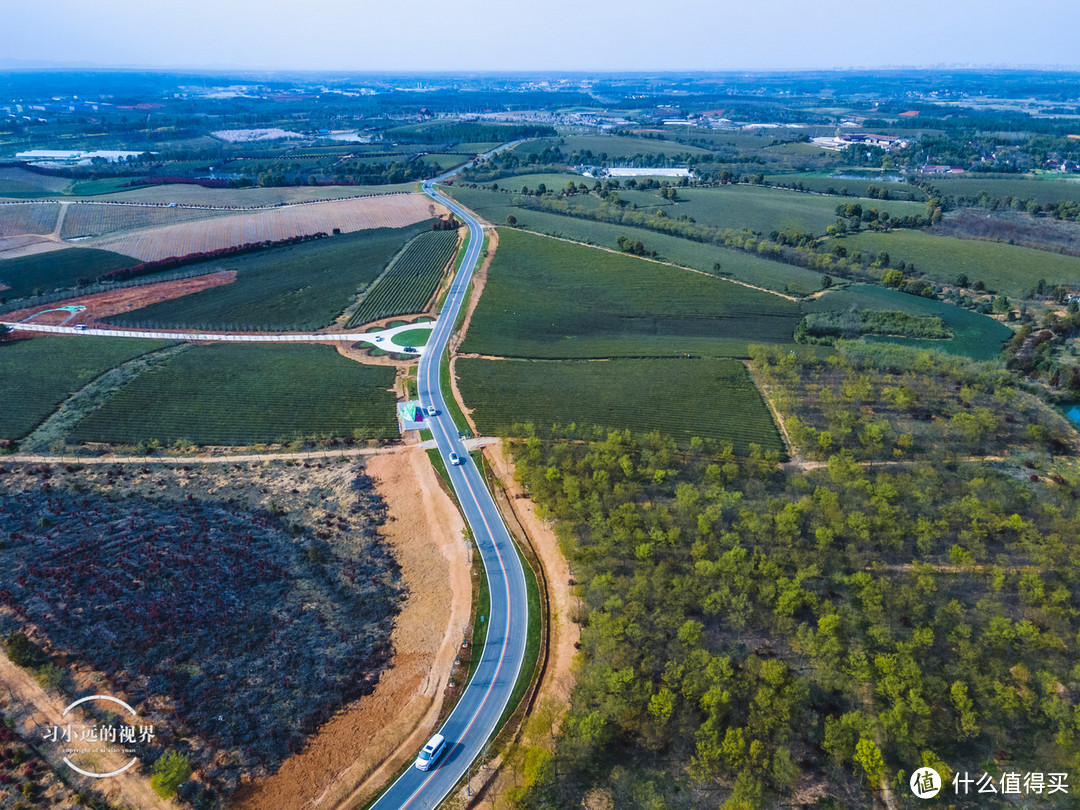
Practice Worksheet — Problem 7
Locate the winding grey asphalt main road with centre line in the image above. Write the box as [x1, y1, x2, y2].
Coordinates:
[373, 181, 528, 810]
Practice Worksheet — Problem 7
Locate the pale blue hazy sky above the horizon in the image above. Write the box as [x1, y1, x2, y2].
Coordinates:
[6, 0, 1080, 70]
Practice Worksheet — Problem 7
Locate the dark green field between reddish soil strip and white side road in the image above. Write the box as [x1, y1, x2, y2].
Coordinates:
[106, 222, 430, 329]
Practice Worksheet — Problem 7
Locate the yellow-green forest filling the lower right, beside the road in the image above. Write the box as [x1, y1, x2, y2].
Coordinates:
[505, 352, 1080, 808]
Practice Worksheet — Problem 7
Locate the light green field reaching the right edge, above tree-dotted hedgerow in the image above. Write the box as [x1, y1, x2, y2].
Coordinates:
[842, 230, 1080, 297]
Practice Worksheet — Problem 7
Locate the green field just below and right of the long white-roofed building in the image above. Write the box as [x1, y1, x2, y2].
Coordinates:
[626, 186, 926, 235]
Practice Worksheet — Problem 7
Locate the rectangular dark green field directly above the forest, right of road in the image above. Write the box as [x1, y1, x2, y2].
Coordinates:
[456, 356, 784, 455]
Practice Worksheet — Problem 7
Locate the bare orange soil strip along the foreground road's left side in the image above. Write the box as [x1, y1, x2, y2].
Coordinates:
[235, 448, 472, 810]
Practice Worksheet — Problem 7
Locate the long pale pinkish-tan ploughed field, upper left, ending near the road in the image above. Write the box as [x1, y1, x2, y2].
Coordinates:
[88, 194, 431, 261]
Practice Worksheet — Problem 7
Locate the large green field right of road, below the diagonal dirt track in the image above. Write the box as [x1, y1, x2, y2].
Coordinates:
[461, 229, 799, 359]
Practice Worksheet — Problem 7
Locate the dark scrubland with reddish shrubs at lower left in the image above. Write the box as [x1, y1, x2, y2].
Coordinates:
[0, 457, 403, 807]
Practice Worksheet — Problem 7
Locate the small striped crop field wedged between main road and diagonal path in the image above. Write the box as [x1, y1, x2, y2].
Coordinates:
[349, 231, 458, 326]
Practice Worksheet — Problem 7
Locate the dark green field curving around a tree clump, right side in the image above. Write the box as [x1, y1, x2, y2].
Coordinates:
[801, 284, 1012, 360]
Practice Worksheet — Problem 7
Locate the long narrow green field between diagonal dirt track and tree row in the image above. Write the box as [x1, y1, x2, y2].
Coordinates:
[447, 186, 821, 294]
